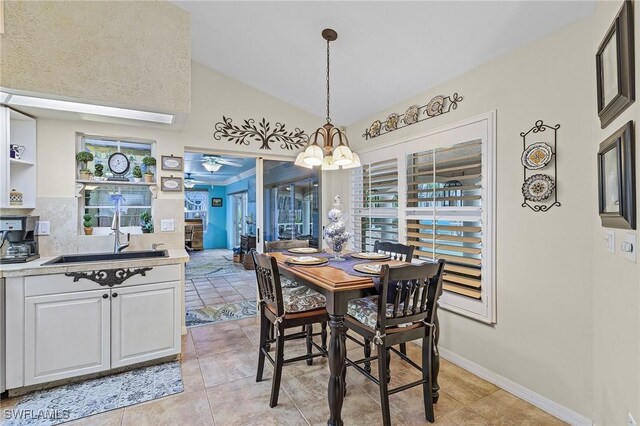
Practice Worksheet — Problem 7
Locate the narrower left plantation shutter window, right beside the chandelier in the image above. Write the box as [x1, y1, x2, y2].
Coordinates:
[351, 158, 398, 251]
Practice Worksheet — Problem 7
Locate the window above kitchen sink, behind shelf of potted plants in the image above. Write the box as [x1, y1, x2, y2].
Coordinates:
[80, 136, 153, 235]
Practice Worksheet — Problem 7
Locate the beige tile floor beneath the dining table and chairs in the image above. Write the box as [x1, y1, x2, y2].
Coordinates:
[3, 318, 563, 426]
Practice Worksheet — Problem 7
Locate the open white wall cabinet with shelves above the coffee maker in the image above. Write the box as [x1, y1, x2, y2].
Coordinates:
[0, 106, 36, 209]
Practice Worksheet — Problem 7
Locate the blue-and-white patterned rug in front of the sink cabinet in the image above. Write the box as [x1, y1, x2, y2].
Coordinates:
[2, 361, 184, 426]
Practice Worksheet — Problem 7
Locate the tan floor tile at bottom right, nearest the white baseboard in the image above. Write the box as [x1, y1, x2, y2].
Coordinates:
[468, 389, 565, 426]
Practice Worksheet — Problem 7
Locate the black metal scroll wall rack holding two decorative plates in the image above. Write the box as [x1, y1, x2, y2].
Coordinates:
[520, 120, 560, 212]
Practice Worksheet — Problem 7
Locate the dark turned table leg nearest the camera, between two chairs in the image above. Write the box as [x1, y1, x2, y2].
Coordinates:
[327, 314, 347, 426]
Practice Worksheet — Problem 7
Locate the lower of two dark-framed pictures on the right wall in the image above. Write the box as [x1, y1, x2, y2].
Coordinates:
[598, 121, 636, 229]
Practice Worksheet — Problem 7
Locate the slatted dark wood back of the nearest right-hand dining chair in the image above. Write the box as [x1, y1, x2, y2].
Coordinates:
[377, 259, 445, 330]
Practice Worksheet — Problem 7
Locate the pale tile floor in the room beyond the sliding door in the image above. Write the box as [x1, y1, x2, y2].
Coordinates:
[185, 250, 256, 309]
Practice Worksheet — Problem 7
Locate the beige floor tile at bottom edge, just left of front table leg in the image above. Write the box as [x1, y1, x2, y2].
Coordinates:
[207, 378, 308, 426]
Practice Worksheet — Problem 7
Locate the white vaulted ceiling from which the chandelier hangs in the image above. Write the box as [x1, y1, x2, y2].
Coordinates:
[175, 0, 595, 125]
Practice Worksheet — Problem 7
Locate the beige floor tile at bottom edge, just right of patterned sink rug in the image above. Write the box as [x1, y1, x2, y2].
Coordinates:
[122, 391, 214, 426]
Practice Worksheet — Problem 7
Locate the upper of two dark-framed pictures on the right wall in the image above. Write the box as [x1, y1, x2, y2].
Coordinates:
[596, 0, 636, 129]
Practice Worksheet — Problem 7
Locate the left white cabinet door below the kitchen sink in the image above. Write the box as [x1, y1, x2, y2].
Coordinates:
[24, 290, 110, 385]
